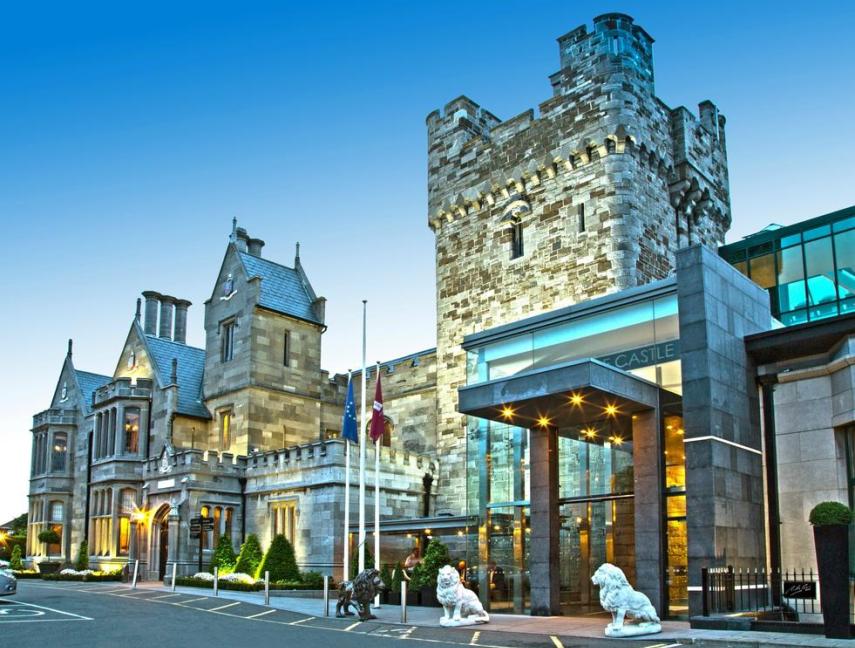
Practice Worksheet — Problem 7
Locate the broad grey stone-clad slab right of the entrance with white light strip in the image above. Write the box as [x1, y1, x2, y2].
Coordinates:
[677, 245, 771, 615]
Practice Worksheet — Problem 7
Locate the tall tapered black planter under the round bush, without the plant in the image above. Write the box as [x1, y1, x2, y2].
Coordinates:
[813, 524, 851, 639]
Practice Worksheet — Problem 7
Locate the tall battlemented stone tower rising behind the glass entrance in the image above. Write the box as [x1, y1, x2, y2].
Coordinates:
[427, 13, 730, 512]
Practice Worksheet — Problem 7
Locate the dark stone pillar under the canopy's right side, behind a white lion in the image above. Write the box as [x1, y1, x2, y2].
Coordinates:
[632, 410, 666, 617]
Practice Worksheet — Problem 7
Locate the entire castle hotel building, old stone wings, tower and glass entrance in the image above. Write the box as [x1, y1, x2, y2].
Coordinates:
[27, 14, 855, 616]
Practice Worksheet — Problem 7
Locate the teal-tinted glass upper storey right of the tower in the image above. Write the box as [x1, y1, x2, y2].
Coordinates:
[719, 207, 855, 326]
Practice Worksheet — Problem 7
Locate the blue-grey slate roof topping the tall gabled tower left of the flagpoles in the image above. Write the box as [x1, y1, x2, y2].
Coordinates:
[238, 252, 323, 324]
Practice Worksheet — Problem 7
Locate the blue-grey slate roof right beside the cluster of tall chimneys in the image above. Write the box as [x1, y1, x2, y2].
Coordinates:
[145, 335, 211, 419]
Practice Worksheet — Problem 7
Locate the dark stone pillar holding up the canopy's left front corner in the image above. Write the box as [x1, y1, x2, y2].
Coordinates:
[529, 428, 561, 616]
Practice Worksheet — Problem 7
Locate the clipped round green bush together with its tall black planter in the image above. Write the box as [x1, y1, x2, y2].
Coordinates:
[810, 502, 852, 639]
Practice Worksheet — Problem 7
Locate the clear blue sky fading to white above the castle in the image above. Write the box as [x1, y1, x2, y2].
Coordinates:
[0, 0, 855, 523]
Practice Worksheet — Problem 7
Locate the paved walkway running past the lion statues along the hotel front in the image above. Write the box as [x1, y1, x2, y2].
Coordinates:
[139, 582, 855, 648]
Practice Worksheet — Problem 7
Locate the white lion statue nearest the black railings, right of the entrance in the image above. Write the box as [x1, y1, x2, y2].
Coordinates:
[591, 563, 662, 637]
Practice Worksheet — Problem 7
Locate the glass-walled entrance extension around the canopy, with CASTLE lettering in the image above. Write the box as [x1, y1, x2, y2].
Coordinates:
[461, 281, 688, 616]
